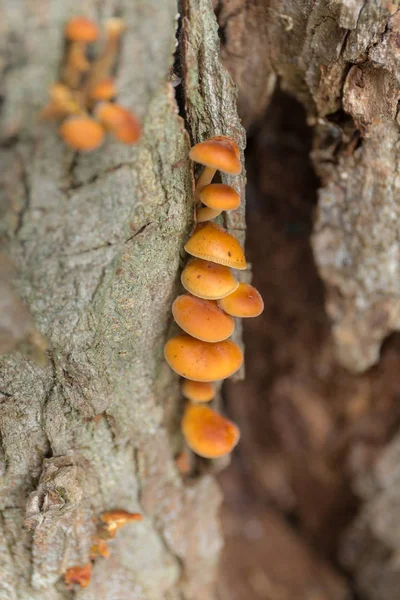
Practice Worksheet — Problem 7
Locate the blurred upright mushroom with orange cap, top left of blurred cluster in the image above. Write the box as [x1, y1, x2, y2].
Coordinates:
[63, 17, 99, 89]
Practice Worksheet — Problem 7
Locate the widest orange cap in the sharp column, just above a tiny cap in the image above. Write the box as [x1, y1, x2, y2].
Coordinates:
[164, 335, 243, 381]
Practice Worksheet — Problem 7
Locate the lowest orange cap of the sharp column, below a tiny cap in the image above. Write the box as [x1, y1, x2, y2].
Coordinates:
[181, 404, 240, 458]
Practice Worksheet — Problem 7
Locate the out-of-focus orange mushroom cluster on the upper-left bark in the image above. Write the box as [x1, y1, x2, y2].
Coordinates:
[41, 17, 140, 152]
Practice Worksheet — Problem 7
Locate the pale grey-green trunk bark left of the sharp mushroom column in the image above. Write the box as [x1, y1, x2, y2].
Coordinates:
[0, 0, 244, 600]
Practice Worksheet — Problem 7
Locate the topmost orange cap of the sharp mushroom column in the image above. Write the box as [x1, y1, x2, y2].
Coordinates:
[189, 135, 242, 175]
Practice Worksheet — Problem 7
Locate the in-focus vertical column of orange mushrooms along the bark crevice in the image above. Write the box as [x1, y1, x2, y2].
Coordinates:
[164, 136, 264, 458]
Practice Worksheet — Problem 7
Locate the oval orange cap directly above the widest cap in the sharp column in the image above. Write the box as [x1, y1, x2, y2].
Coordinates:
[172, 294, 235, 342]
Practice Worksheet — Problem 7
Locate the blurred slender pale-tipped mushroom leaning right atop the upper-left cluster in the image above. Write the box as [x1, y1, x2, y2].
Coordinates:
[84, 18, 125, 97]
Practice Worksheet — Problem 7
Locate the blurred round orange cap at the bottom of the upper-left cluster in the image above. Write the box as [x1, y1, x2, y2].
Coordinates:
[58, 115, 104, 152]
